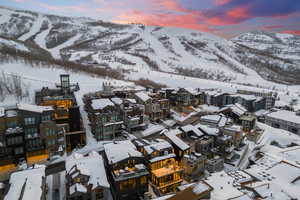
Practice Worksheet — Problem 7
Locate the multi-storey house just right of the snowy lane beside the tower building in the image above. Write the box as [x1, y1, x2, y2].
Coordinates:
[86, 98, 123, 141]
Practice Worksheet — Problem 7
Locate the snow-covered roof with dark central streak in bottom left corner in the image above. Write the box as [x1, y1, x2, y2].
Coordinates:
[4, 165, 45, 200]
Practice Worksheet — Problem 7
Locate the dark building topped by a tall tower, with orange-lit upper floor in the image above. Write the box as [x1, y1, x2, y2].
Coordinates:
[35, 74, 86, 152]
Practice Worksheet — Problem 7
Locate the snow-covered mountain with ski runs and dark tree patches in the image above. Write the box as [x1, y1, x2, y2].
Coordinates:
[0, 7, 300, 84]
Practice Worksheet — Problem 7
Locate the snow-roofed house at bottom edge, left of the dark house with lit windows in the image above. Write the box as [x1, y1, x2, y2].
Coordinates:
[66, 151, 110, 200]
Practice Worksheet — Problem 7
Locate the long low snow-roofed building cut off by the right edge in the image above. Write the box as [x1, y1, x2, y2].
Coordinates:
[265, 110, 300, 135]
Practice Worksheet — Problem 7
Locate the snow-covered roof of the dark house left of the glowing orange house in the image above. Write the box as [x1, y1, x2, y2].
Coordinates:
[104, 140, 143, 164]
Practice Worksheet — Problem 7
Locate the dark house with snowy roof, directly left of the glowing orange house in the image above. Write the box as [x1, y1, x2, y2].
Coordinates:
[104, 140, 149, 199]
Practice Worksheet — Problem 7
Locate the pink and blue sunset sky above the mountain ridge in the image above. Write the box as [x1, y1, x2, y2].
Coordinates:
[0, 0, 300, 38]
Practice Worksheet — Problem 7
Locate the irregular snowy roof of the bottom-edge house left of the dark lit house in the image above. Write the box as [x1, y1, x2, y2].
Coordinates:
[66, 151, 110, 189]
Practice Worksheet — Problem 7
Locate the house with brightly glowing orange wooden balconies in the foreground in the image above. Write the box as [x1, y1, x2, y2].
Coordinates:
[136, 139, 183, 194]
